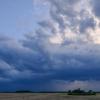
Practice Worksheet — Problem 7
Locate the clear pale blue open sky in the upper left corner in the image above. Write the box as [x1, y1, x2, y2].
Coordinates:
[0, 0, 34, 39]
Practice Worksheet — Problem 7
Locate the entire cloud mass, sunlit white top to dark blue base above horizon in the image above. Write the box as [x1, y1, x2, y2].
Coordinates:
[0, 0, 100, 90]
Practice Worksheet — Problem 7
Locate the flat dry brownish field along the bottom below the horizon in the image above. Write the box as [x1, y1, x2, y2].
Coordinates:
[0, 93, 100, 100]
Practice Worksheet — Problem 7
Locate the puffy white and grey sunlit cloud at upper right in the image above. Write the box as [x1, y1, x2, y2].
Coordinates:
[36, 0, 99, 44]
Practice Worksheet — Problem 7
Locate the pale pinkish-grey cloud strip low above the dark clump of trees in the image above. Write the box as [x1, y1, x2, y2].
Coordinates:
[52, 80, 100, 91]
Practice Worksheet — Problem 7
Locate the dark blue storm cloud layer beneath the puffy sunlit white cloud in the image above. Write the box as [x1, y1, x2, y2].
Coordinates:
[0, 33, 100, 91]
